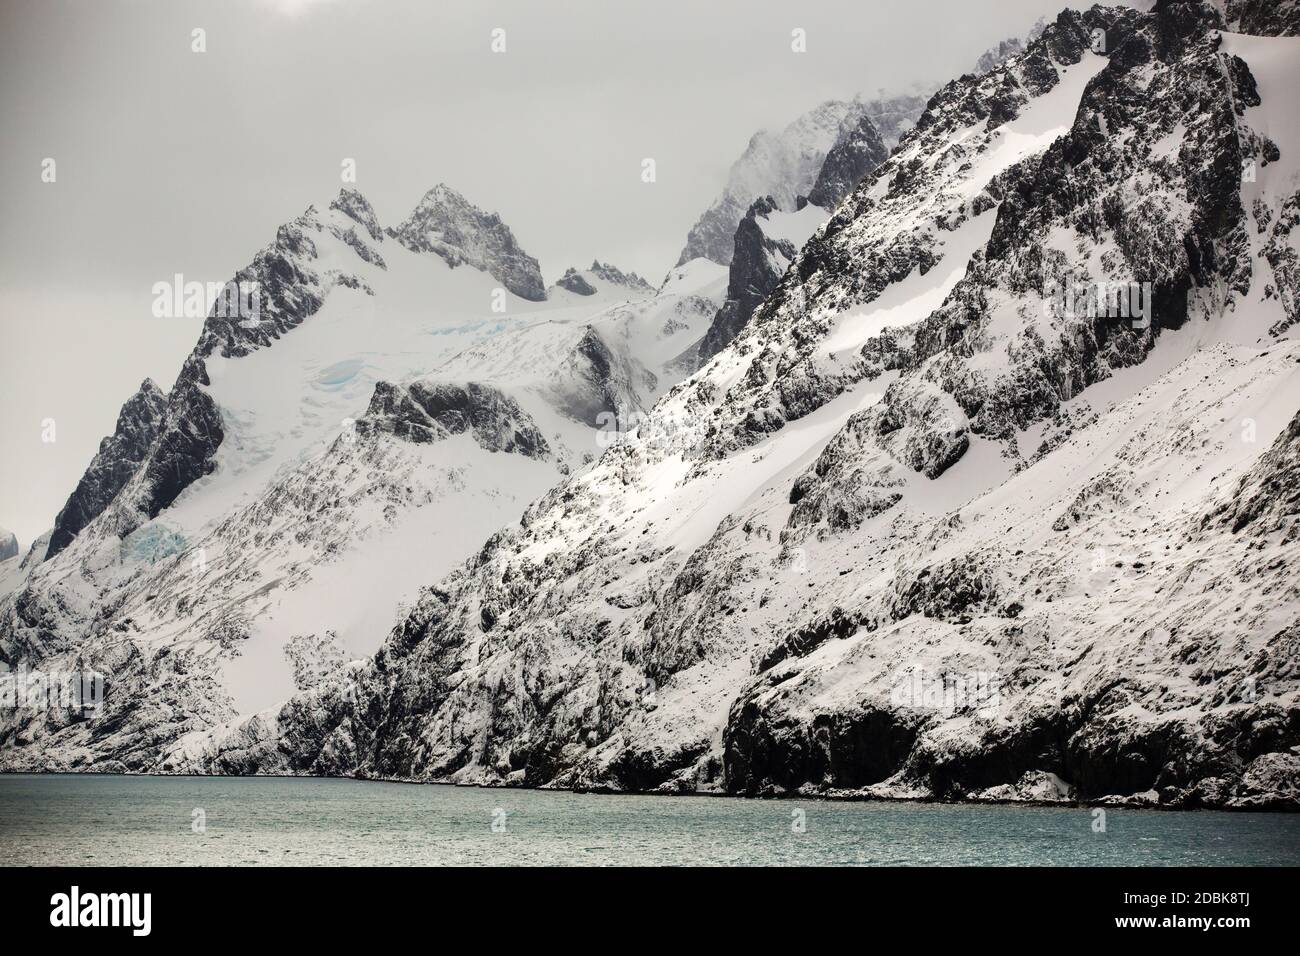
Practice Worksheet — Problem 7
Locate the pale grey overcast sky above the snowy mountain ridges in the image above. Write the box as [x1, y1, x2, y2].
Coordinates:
[0, 0, 1081, 546]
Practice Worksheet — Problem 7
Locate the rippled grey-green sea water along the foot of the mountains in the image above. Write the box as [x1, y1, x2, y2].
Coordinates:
[0, 775, 1300, 866]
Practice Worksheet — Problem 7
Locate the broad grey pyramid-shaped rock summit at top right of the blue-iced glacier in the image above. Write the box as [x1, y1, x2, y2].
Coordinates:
[389, 183, 546, 302]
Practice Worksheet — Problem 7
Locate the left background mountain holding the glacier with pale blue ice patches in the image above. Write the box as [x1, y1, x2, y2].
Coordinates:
[0, 186, 725, 749]
